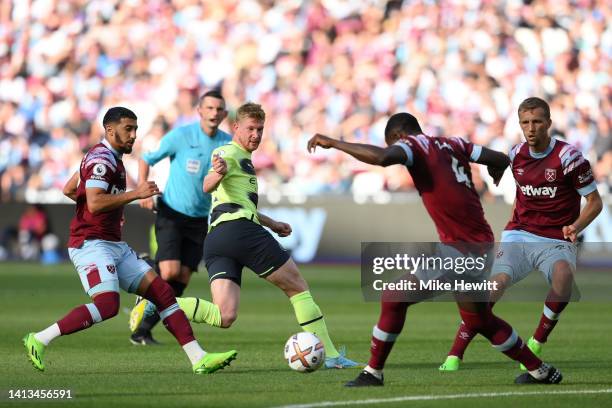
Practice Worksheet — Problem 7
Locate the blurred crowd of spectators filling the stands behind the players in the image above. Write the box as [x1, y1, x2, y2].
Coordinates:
[0, 0, 612, 202]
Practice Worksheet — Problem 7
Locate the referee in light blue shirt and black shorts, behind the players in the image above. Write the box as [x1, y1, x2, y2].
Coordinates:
[130, 90, 231, 345]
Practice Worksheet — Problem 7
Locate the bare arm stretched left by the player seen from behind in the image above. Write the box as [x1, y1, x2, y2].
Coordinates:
[308, 133, 408, 167]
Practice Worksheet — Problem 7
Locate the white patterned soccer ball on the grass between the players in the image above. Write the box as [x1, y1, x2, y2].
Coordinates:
[285, 332, 325, 373]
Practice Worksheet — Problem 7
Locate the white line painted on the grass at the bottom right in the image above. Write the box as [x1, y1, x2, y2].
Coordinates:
[276, 388, 612, 408]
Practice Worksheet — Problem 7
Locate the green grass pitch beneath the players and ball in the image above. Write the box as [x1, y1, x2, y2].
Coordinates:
[0, 264, 612, 408]
